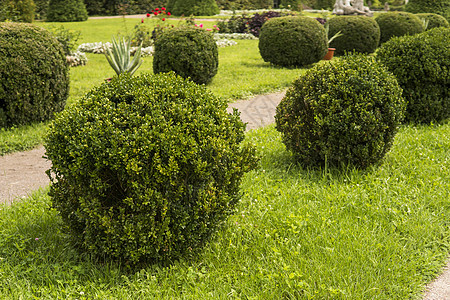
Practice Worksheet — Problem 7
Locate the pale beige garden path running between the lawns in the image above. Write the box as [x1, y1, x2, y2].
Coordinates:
[0, 92, 450, 300]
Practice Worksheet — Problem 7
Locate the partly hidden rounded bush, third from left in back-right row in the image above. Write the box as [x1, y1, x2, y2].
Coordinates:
[375, 12, 423, 44]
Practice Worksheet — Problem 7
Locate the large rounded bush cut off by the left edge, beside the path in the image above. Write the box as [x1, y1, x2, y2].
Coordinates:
[0, 23, 69, 128]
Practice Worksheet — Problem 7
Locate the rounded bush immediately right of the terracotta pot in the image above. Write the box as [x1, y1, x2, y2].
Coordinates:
[328, 16, 380, 55]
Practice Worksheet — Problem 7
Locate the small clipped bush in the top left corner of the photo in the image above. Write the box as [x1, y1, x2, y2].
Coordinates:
[0, 0, 35, 23]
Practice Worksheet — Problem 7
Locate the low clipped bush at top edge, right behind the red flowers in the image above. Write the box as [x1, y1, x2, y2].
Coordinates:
[167, 0, 220, 16]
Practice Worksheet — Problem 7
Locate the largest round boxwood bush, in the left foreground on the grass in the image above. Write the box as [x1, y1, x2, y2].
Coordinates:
[45, 73, 256, 264]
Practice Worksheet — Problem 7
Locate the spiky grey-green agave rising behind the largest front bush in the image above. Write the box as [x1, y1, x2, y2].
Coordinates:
[105, 37, 142, 75]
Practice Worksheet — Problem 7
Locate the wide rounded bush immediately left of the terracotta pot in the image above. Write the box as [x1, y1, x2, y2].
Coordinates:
[258, 17, 328, 66]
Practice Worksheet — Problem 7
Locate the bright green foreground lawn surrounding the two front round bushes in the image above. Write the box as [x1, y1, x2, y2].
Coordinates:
[0, 122, 450, 299]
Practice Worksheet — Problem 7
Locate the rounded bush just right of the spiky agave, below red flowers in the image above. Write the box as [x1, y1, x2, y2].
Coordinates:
[153, 26, 219, 84]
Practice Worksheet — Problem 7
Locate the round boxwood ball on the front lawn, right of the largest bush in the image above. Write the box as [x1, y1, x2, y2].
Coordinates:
[275, 54, 406, 168]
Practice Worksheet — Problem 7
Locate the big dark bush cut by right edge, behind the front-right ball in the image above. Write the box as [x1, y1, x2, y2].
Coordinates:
[377, 27, 450, 123]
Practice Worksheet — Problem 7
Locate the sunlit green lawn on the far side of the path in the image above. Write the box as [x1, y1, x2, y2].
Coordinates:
[0, 18, 305, 155]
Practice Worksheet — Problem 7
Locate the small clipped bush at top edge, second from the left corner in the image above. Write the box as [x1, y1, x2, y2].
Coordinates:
[47, 0, 88, 22]
